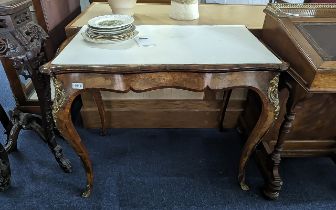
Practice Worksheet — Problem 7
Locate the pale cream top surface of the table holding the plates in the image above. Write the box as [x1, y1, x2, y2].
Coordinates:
[52, 25, 281, 65]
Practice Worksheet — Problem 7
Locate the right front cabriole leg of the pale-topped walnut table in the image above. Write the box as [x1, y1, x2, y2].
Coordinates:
[238, 75, 280, 190]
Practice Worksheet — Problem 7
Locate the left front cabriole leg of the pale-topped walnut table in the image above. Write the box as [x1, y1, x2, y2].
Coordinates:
[53, 83, 93, 197]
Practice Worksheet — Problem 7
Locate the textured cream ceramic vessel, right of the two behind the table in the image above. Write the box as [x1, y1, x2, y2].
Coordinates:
[169, 0, 199, 20]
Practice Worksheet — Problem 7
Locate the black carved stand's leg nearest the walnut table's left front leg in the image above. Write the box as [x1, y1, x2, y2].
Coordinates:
[31, 71, 72, 173]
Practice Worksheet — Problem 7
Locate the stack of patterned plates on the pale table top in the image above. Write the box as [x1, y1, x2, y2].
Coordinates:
[82, 15, 138, 44]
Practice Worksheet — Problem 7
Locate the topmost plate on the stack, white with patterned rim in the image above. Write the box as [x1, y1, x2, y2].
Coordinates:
[88, 15, 134, 29]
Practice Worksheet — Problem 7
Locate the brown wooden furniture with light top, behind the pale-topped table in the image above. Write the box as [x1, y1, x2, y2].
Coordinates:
[65, 2, 265, 128]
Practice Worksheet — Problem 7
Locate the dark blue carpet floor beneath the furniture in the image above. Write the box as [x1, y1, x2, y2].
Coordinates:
[0, 62, 336, 210]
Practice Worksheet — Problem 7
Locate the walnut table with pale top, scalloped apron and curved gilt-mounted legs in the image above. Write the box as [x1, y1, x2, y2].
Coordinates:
[42, 25, 287, 197]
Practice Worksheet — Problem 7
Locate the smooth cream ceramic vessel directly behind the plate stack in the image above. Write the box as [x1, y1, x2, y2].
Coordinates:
[108, 0, 137, 16]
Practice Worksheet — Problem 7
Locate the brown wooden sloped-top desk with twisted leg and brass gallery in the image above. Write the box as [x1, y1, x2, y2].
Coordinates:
[241, 4, 336, 198]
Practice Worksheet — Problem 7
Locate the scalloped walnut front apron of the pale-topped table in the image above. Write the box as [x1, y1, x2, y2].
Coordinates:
[56, 71, 277, 94]
